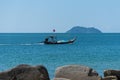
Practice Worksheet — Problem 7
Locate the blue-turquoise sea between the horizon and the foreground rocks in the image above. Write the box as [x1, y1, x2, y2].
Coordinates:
[0, 33, 120, 79]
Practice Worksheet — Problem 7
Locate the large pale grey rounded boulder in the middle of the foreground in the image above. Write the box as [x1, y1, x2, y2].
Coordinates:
[55, 65, 100, 80]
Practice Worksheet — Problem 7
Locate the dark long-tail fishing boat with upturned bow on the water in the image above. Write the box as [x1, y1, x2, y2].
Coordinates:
[44, 36, 76, 44]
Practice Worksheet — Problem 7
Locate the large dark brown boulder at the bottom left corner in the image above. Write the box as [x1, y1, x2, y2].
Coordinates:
[0, 64, 50, 80]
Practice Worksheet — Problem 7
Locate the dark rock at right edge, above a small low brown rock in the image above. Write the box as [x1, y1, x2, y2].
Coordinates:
[104, 70, 120, 80]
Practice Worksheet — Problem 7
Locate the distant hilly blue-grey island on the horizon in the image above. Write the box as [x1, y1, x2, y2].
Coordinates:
[66, 26, 102, 33]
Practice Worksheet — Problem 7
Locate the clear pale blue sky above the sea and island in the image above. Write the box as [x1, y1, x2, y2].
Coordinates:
[0, 0, 120, 33]
